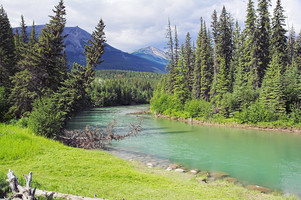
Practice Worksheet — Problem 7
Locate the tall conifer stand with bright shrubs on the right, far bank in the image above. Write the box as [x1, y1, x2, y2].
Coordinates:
[151, 0, 301, 123]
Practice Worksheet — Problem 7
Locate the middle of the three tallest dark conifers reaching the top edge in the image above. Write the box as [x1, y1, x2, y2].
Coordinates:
[255, 0, 271, 86]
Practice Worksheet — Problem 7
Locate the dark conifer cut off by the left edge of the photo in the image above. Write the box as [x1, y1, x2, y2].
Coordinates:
[0, 6, 17, 87]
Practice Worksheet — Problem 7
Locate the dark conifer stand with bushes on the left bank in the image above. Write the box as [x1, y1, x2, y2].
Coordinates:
[0, 0, 105, 137]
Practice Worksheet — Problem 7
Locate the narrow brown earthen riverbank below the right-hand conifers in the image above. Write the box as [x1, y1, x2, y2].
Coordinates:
[154, 111, 301, 134]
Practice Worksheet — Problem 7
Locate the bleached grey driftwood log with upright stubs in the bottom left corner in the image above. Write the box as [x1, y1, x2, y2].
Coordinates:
[7, 170, 105, 200]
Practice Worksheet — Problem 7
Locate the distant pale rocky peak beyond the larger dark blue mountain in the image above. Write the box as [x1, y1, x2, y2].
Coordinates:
[131, 46, 168, 65]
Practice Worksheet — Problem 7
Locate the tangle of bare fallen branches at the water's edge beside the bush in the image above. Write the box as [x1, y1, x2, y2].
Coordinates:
[58, 120, 142, 149]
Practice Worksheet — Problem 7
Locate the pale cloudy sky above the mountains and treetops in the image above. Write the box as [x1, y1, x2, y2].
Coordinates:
[0, 0, 301, 52]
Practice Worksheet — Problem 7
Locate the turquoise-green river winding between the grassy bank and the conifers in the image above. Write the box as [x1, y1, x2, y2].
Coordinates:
[67, 105, 301, 197]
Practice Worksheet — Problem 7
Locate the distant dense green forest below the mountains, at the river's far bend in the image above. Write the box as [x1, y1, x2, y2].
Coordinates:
[89, 70, 163, 106]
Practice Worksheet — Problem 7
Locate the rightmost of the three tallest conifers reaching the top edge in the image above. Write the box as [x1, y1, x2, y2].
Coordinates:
[271, 0, 288, 70]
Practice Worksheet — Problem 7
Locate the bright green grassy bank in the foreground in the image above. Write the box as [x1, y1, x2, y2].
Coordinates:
[0, 124, 296, 200]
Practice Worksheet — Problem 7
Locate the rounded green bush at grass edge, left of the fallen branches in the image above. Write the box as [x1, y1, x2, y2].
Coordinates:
[28, 97, 64, 138]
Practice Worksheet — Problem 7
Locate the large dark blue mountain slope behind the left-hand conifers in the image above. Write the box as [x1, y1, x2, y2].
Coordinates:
[14, 25, 166, 73]
